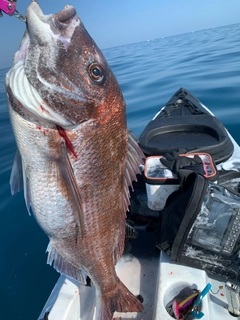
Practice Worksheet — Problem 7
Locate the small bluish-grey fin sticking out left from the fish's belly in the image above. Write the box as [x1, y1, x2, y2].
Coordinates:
[9, 150, 23, 195]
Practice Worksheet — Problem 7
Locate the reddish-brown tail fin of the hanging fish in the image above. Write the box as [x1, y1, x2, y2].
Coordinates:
[97, 281, 144, 320]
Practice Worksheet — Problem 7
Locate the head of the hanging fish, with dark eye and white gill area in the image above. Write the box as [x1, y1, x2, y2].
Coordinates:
[6, 2, 126, 128]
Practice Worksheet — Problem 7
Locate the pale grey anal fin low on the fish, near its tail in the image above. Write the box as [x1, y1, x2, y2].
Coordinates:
[46, 242, 87, 285]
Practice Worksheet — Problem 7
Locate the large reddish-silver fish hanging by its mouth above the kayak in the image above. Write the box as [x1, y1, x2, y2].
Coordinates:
[6, 1, 144, 320]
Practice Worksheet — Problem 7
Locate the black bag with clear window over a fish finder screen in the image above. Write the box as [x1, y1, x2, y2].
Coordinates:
[157, 172, 240, 281]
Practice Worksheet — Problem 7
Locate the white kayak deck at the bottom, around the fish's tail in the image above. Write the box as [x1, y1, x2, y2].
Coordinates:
[38, 239, 240, 320]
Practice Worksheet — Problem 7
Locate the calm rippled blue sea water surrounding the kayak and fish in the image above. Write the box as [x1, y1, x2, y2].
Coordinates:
[0, 24, 240, 320]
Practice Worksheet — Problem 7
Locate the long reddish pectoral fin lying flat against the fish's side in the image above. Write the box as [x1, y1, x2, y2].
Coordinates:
[49, 139, 84, 238]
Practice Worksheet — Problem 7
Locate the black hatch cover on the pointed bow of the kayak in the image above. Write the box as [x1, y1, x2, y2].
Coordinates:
[139, 88, 234, 164]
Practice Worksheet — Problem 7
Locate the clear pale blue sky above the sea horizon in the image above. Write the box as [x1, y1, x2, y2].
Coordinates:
[0, 0, 240, 68]
